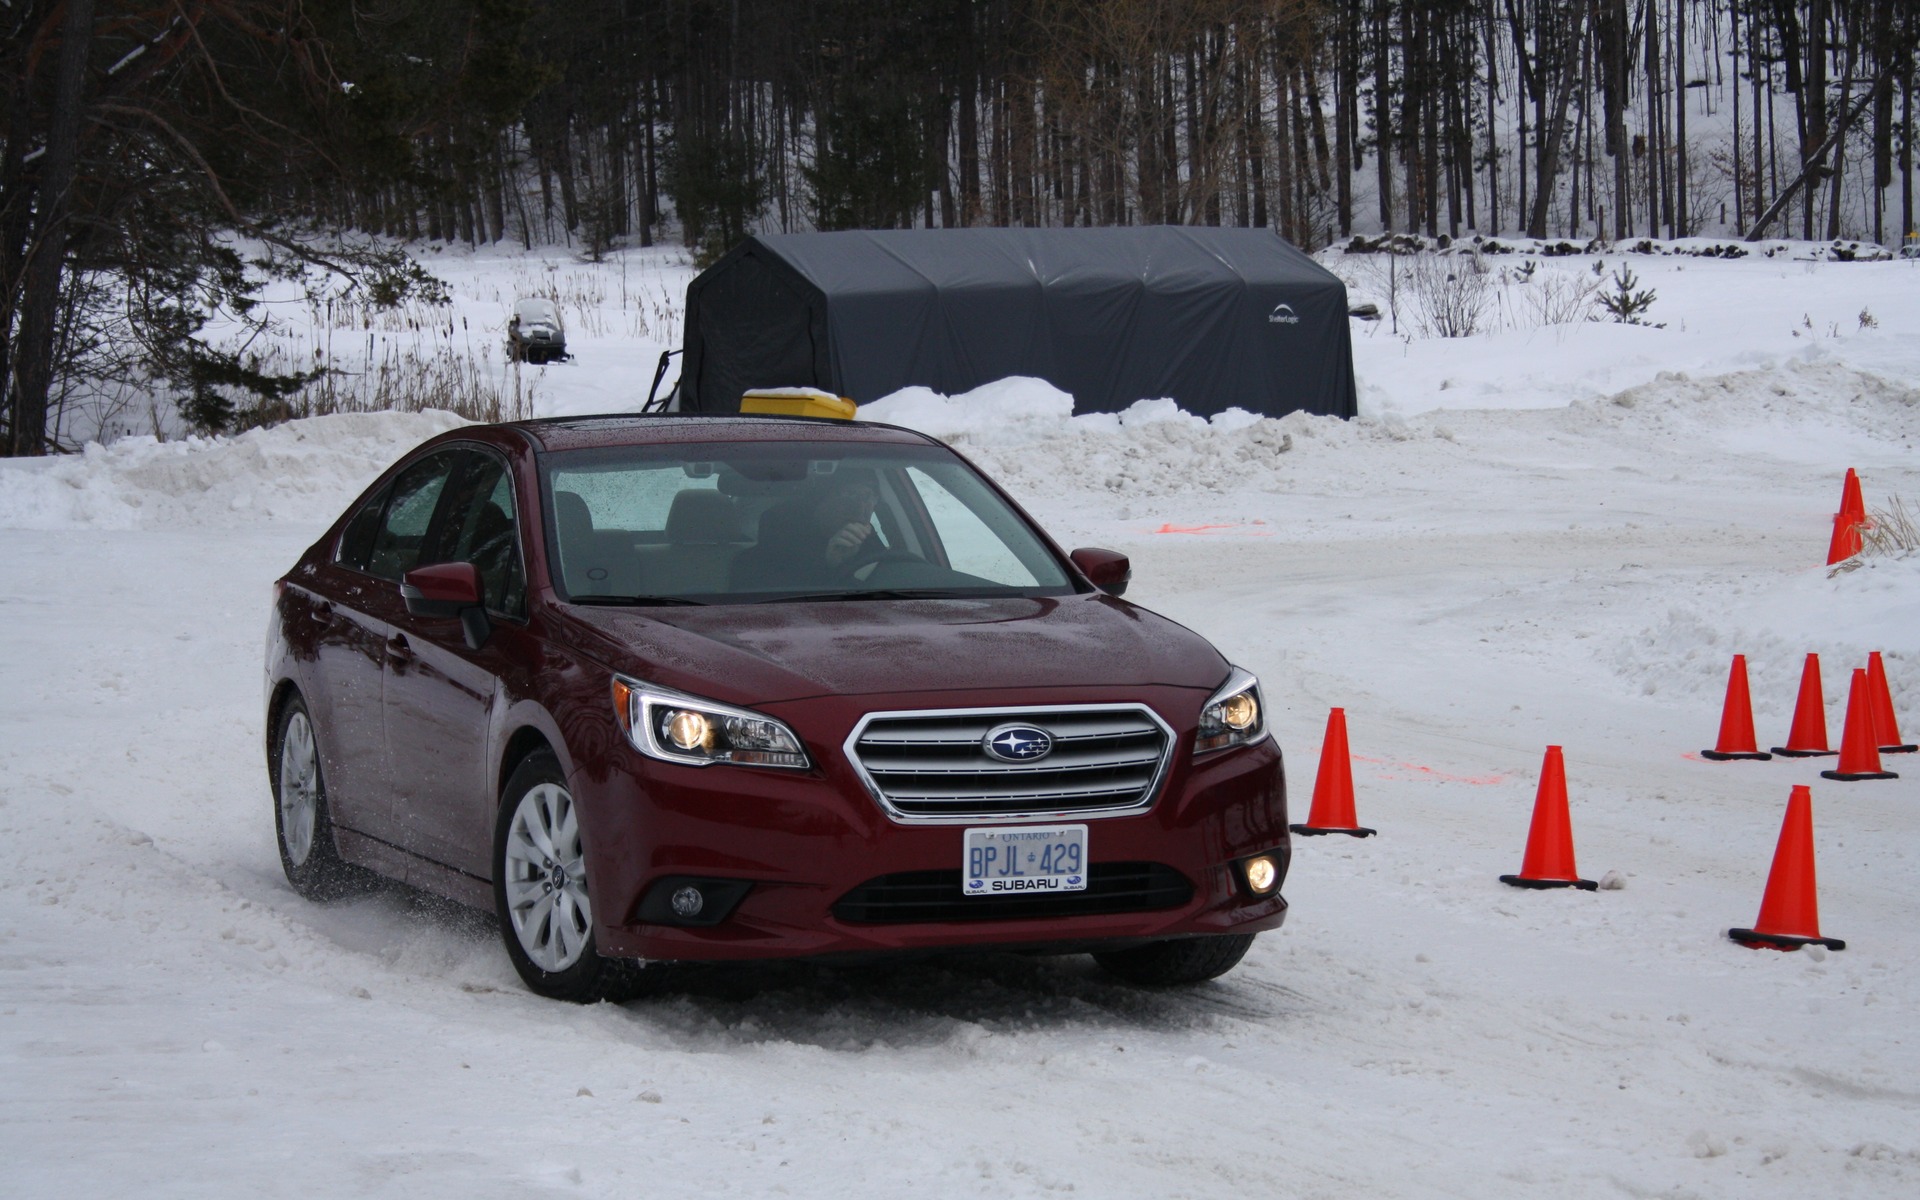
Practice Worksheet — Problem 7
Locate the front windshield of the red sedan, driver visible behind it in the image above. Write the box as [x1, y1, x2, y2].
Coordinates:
[541, 442, 1073, 605]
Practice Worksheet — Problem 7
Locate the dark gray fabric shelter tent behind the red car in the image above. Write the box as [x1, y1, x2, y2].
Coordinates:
[680, 225, 1356, 417]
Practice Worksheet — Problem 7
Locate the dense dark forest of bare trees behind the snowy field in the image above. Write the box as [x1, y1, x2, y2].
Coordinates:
[0, 0, 1920, 453]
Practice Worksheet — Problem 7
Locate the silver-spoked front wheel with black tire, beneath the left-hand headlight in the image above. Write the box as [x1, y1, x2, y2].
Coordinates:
[493, 753, 651, 1004]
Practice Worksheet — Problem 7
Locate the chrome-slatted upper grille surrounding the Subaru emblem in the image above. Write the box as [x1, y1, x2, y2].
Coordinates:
[847, 705, 1173, 824]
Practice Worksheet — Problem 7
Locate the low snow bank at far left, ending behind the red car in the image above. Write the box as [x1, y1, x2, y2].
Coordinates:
[0, 413, 465, 530]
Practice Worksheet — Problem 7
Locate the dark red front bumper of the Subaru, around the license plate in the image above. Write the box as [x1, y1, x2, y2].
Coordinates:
[572, 689, 1288, 960]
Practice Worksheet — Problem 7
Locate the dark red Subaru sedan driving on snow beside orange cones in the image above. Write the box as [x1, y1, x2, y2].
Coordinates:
[267, 417, 1288, 1000]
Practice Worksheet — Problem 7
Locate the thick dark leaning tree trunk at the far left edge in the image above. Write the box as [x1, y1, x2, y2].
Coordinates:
[8, 0, 94, 457]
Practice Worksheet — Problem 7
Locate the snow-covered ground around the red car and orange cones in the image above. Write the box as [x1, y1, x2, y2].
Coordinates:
[0, 243, 1920, 1198]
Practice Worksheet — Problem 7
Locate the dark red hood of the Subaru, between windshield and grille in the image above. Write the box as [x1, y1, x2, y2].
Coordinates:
[570, 593, 1227, 705]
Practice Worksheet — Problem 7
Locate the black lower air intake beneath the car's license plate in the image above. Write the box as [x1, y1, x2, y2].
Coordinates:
[833, 862, 1194, 925]
